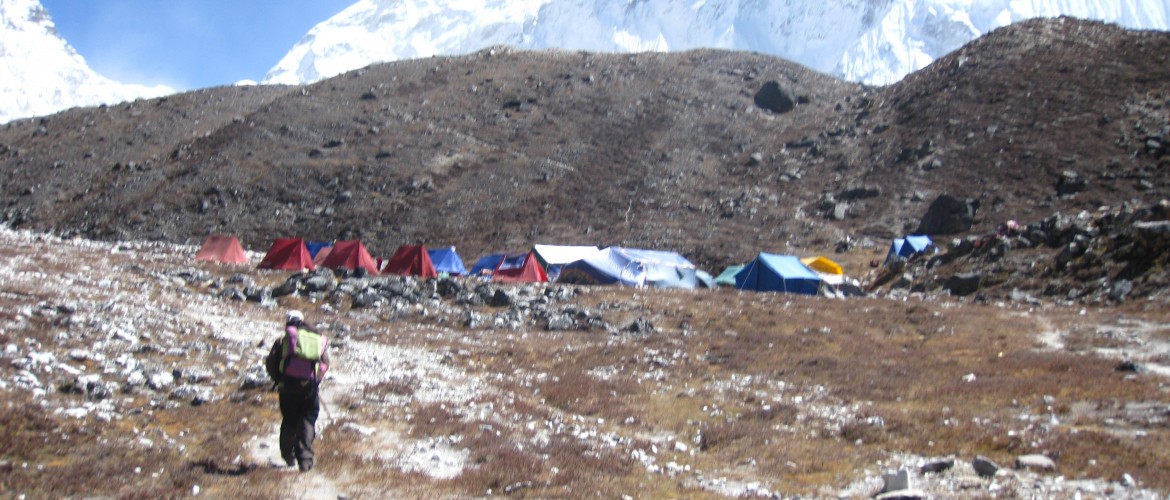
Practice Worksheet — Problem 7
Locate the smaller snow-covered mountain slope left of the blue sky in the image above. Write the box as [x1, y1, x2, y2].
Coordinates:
[0, 0, 173, 123]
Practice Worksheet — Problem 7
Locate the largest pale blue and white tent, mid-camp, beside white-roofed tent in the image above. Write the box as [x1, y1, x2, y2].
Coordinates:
[559, 247, 696, 288]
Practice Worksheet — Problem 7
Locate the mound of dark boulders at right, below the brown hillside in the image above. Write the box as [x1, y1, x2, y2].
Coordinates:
[873, 200, 1170, 304]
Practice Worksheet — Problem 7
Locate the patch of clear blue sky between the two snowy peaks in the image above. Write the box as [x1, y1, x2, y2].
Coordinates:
[41, 0, 357, 90]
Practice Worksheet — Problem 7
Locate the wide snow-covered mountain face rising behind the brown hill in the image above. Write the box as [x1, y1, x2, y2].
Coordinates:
[266, 0, 1170, 84]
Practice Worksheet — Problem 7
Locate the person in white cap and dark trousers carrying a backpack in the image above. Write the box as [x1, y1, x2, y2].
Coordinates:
[264, 310, 329, 472]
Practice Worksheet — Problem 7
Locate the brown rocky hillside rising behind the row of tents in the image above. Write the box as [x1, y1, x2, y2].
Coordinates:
[0, 19, 1170, 302]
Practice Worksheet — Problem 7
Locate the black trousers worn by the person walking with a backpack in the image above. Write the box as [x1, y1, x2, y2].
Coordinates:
[280, 379, 321, 470]
